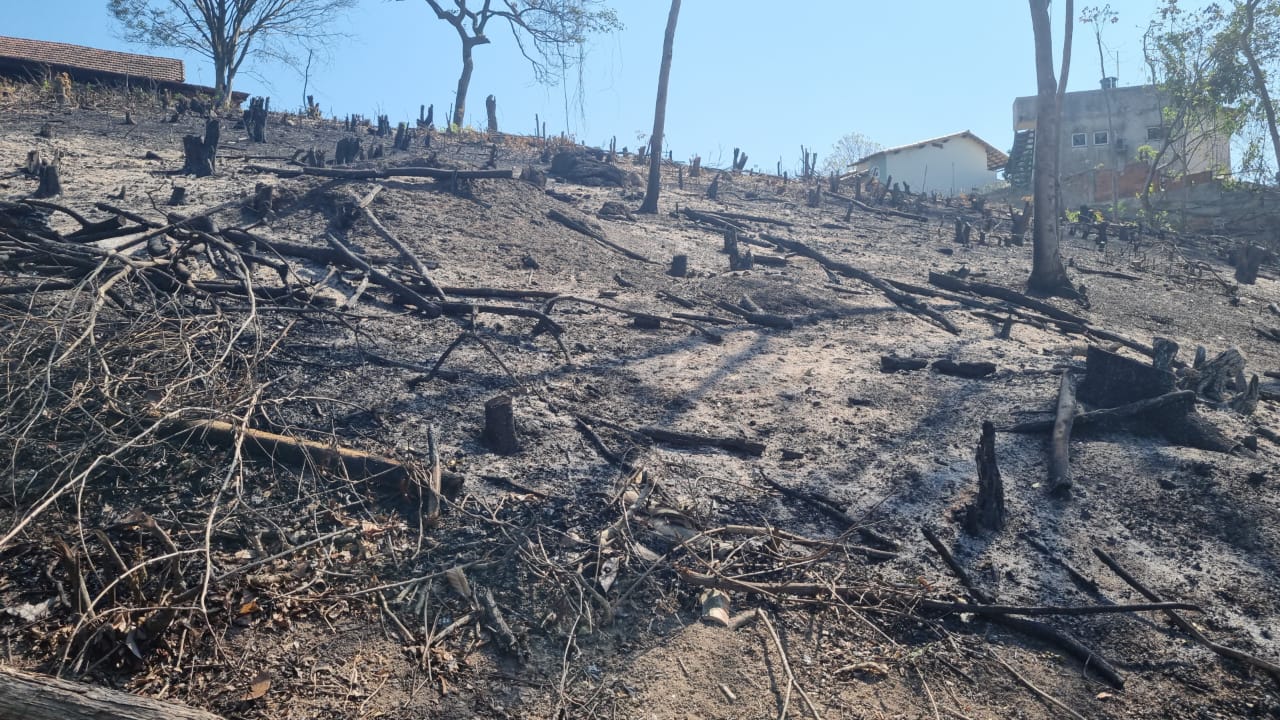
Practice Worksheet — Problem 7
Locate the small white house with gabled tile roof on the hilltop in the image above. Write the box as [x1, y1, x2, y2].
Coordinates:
[854, 131, 1009, 195]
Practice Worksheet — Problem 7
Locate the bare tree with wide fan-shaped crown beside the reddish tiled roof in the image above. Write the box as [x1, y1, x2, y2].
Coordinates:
[106, 0, 357, 101]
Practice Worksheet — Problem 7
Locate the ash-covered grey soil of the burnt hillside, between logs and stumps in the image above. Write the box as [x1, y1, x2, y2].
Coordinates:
[0, 85, 1280, 719]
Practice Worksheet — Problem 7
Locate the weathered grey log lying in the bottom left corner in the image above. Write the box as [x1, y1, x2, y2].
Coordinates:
[0, 667, 221, 720]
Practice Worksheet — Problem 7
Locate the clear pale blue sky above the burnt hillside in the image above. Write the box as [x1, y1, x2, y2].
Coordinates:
[10, 0, 1158, 172]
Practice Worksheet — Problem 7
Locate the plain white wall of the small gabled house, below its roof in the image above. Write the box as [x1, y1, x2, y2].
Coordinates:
[881, 137, 996, 195]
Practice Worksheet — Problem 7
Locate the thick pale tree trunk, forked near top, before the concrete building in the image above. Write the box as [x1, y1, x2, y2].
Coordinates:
[1027, 0, 1075, 295]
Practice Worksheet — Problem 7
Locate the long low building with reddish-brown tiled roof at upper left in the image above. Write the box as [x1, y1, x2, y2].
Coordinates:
[0, 36, 248, 105]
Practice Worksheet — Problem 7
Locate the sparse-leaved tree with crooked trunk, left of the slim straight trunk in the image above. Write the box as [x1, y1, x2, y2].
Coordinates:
[426, 0, 622, 126]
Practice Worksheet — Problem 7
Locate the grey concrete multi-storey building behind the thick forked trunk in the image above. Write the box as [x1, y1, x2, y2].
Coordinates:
[1006, 78, 1231, 206]
